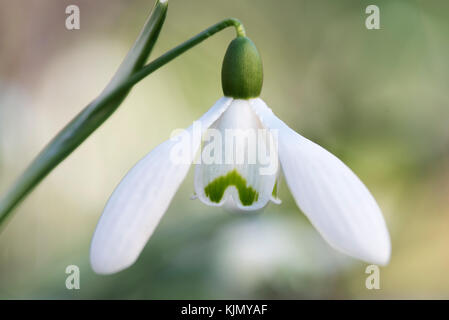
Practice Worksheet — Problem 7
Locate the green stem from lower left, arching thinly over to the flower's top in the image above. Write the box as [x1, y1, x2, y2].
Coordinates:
[0, 16, 245, 225]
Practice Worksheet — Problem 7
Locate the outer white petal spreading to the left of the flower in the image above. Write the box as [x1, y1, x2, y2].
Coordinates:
[90, 98, 232, 274]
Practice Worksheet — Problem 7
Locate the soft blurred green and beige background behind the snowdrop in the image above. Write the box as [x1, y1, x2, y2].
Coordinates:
[0, 0, 449, 299]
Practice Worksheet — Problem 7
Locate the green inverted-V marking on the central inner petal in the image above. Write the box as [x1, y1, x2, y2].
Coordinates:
[204, 169, 259, 206]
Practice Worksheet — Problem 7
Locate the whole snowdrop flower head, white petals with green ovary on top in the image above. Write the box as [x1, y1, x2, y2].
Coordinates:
[90, 36, 390, 274]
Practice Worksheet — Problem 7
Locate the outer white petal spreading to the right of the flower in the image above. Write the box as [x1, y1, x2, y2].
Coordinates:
[251, 98, 391, 265]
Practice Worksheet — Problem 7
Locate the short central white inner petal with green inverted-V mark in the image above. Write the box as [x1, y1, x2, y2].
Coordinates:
[195, 100, 279, 211]
